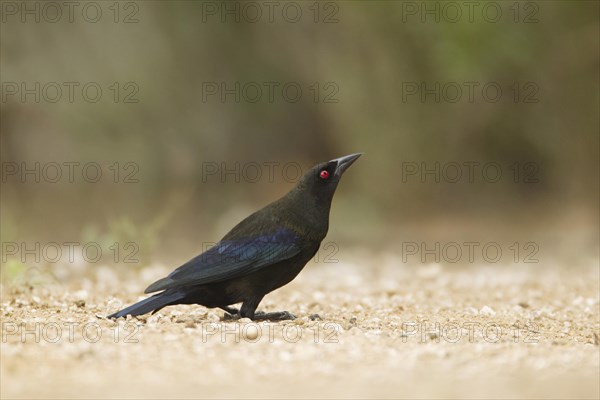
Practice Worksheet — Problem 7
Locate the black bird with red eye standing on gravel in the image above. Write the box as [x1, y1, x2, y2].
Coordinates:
[108, 153, 362, 320]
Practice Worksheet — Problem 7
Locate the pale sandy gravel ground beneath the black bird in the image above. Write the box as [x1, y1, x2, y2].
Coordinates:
[0, 255, 600, 398]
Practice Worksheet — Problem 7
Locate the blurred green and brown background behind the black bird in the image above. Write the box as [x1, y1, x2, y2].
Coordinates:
[0, 1, 600, 265]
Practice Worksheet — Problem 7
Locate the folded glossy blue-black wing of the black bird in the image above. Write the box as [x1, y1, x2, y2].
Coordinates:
[145, 228, 301, 293]
